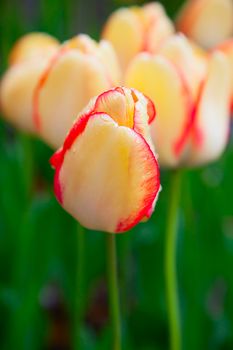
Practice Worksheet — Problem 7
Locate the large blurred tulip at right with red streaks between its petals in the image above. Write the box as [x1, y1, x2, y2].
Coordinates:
[126, 35, 231, 167]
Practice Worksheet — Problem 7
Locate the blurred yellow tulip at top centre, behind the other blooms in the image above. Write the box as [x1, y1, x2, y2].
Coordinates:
[103, 2, 174, 70]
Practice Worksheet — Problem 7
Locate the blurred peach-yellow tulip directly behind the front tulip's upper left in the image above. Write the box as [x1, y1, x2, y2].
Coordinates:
[34, 35, 120, 148]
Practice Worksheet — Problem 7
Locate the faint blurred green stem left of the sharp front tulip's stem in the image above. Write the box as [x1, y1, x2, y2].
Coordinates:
[75, 224, 85, 350]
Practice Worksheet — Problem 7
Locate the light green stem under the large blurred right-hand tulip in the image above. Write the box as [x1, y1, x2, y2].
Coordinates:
[165, 170, 181, 350]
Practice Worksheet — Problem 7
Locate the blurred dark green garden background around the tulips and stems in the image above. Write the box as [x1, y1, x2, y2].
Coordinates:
[0, 0, 233, 350]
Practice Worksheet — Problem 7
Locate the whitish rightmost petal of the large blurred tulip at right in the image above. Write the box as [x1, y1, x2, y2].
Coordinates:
[190, 52, 231, 165]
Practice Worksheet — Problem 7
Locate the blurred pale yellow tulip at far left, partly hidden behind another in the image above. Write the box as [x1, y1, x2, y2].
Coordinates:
[0, 33, 59, 133]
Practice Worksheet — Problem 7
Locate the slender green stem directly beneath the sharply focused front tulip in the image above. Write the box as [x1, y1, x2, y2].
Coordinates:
[106, 233, 121, 350]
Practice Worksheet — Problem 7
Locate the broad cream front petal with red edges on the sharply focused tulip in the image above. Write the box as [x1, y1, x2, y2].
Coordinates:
[53, 113, 160, 232]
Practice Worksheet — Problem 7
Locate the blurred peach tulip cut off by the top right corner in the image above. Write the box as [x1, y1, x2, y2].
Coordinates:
[177, 0, 233, 49]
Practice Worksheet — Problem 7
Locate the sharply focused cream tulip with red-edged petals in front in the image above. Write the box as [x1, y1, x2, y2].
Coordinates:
[51, 88, 160, 233]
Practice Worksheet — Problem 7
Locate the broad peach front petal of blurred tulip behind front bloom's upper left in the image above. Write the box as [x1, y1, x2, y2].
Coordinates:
[34, 49, 111, 148]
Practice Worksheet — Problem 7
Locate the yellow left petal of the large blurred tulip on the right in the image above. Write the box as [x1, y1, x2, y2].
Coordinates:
[126, 54, 193, 166]
